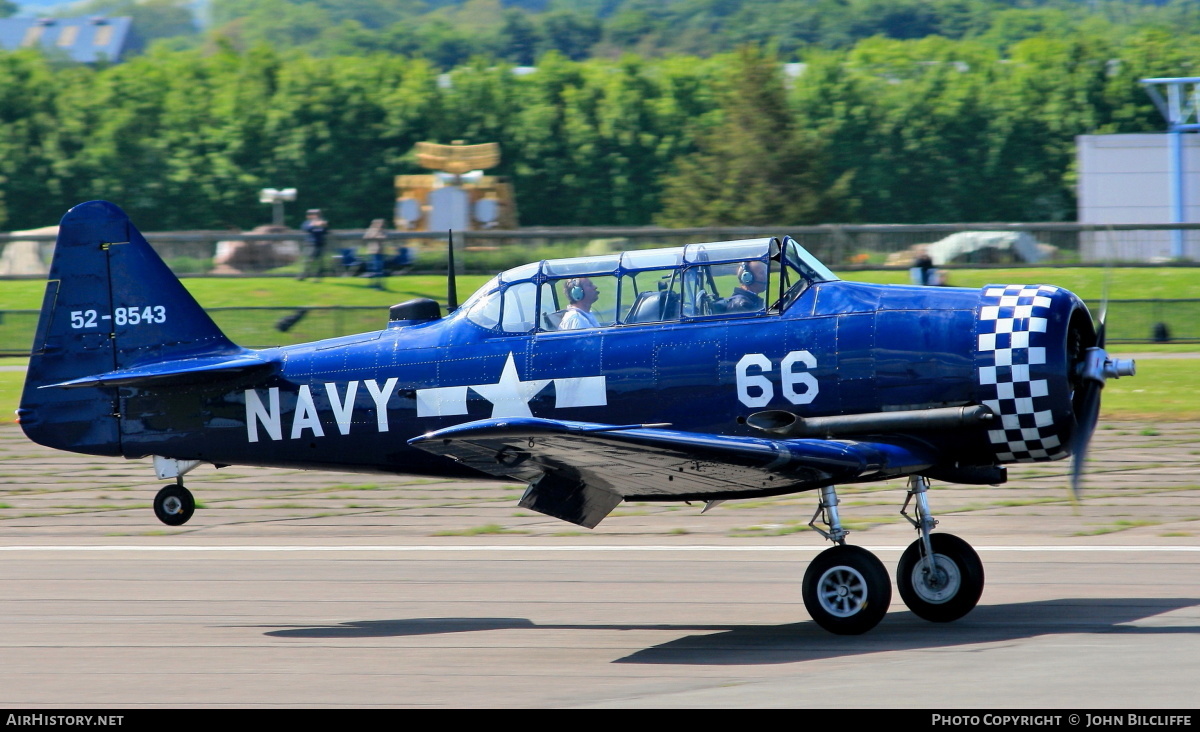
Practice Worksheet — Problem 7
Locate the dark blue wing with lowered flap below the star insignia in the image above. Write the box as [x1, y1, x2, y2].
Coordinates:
[409, 418, 937, 528]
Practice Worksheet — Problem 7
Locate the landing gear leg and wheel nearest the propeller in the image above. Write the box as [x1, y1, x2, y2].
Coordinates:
[896, 475, 983, 623]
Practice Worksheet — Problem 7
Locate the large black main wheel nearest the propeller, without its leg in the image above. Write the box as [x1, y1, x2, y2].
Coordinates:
[896, 534, 983, 623]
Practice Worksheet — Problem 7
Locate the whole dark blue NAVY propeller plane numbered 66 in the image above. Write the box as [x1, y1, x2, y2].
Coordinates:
[18, 202, 1134, 634]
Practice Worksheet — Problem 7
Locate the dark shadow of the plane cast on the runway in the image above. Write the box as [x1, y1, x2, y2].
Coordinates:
[265, 598, 1200, 666]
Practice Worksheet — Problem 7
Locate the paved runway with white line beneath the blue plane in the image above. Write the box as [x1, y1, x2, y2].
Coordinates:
[0, 424, 1200, 712]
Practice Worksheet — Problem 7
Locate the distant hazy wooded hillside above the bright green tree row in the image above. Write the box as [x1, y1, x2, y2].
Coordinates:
[54, 0, 1200, 70]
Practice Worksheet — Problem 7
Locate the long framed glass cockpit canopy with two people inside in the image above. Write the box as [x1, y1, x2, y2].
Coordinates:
[460, 236, 838, 334]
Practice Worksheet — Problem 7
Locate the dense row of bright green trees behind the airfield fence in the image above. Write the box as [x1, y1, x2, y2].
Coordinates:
[0, 29, 1198, 230]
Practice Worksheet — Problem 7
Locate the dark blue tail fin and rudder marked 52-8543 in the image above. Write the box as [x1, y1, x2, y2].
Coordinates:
[17, 200, 244, 455]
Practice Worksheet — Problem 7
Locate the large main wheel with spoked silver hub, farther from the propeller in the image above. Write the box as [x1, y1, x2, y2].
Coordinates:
[803, 545, 892, 636]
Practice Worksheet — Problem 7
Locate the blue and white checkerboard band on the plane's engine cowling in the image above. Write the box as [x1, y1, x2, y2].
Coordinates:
[978, 284, 1067, 462]
